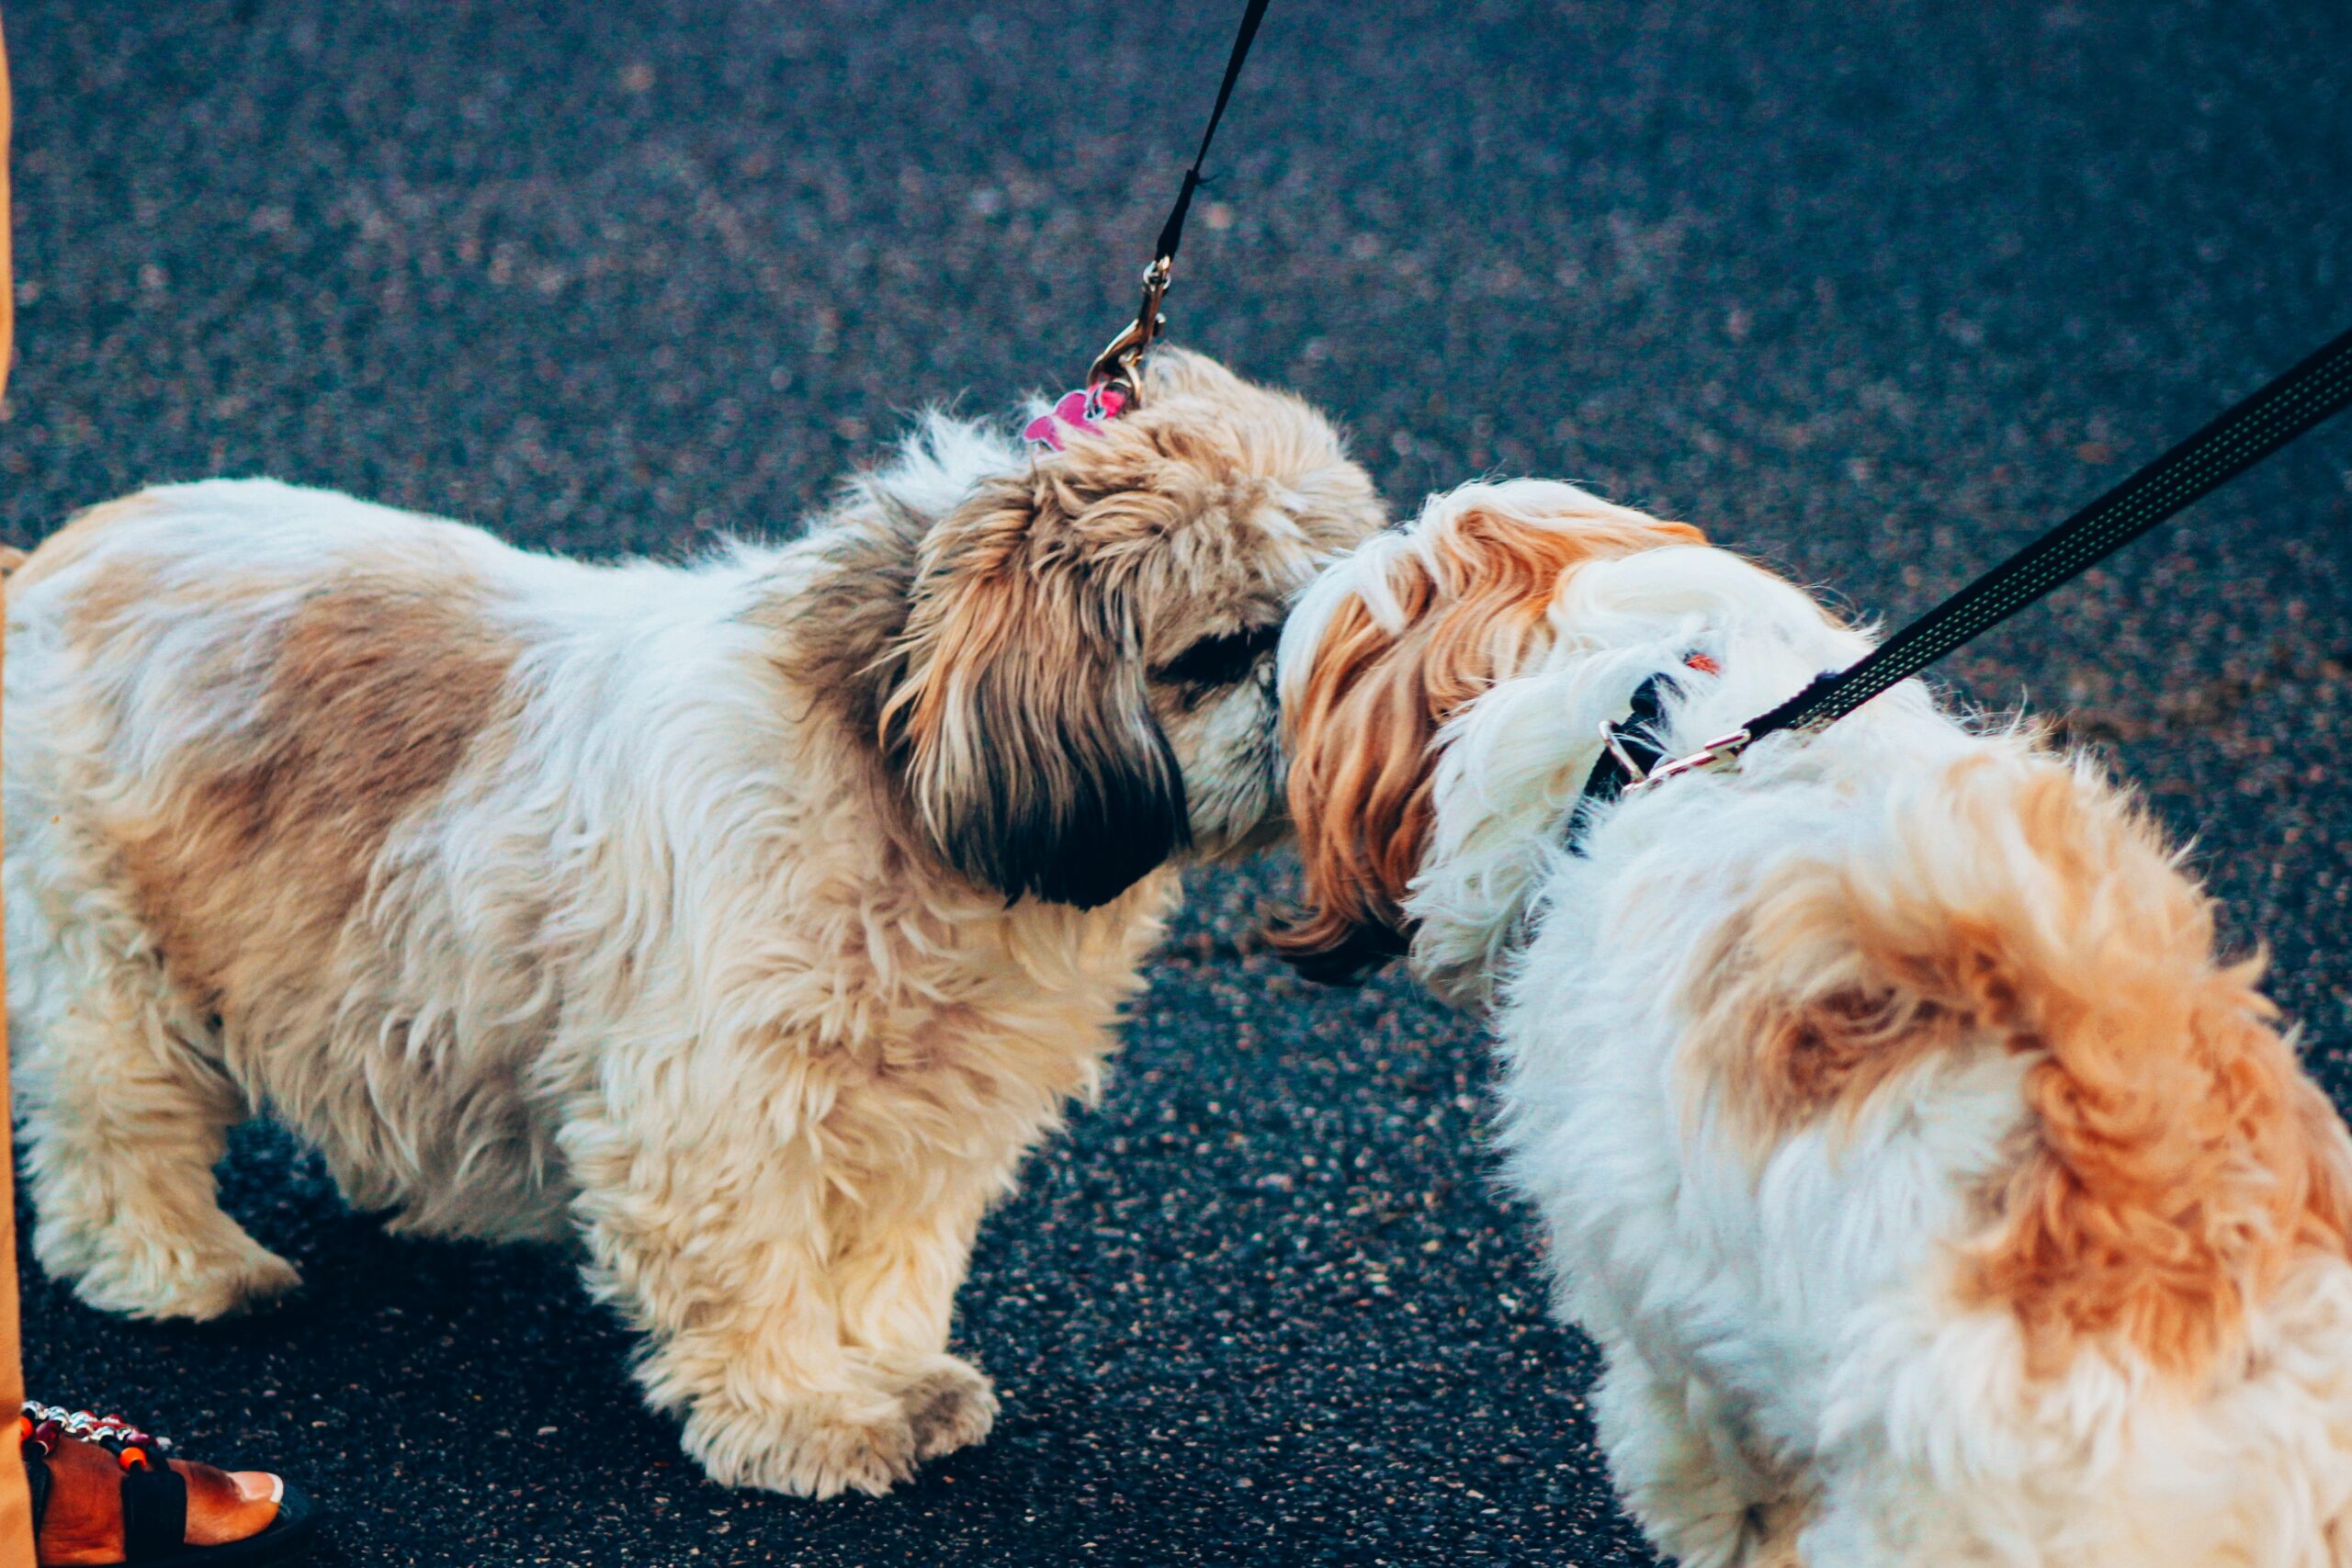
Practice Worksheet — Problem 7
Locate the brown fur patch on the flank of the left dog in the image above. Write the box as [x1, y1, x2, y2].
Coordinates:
[120, 579, 515, 1009]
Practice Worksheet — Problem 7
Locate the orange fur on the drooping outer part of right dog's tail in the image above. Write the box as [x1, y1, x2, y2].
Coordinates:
[1952, 766, 2352, 1375]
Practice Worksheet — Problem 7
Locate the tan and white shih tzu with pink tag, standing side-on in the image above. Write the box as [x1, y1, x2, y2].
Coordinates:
[7, 350, 1381, 1495]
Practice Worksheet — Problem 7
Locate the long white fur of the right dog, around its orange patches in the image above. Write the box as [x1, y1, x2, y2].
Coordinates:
[1282, 482, 2352, 1568]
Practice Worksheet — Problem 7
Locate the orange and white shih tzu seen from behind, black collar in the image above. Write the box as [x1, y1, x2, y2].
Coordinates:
[1280, 482, 2352, 1568]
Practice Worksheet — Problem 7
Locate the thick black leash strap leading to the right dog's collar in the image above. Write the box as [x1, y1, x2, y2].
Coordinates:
[1747, 332, 2352, 740]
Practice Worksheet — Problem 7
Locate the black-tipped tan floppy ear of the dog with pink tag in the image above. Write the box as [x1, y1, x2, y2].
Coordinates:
[882, 478, 1193, 908]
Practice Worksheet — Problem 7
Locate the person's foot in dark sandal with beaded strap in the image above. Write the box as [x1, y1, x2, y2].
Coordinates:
[17, 1401, 318, 1568]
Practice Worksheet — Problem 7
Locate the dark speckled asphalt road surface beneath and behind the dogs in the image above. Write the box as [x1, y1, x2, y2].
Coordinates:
[0, 0, 2352, 1568]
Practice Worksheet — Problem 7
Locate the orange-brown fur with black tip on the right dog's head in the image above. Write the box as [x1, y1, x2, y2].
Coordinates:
[1272, 510, 1705, 974]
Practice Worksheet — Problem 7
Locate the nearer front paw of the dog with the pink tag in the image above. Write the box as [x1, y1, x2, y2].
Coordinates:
[684, 1394, 915, 1497]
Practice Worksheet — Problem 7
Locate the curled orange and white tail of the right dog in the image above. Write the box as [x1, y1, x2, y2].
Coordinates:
[1701, 740, 2352, 1378]
